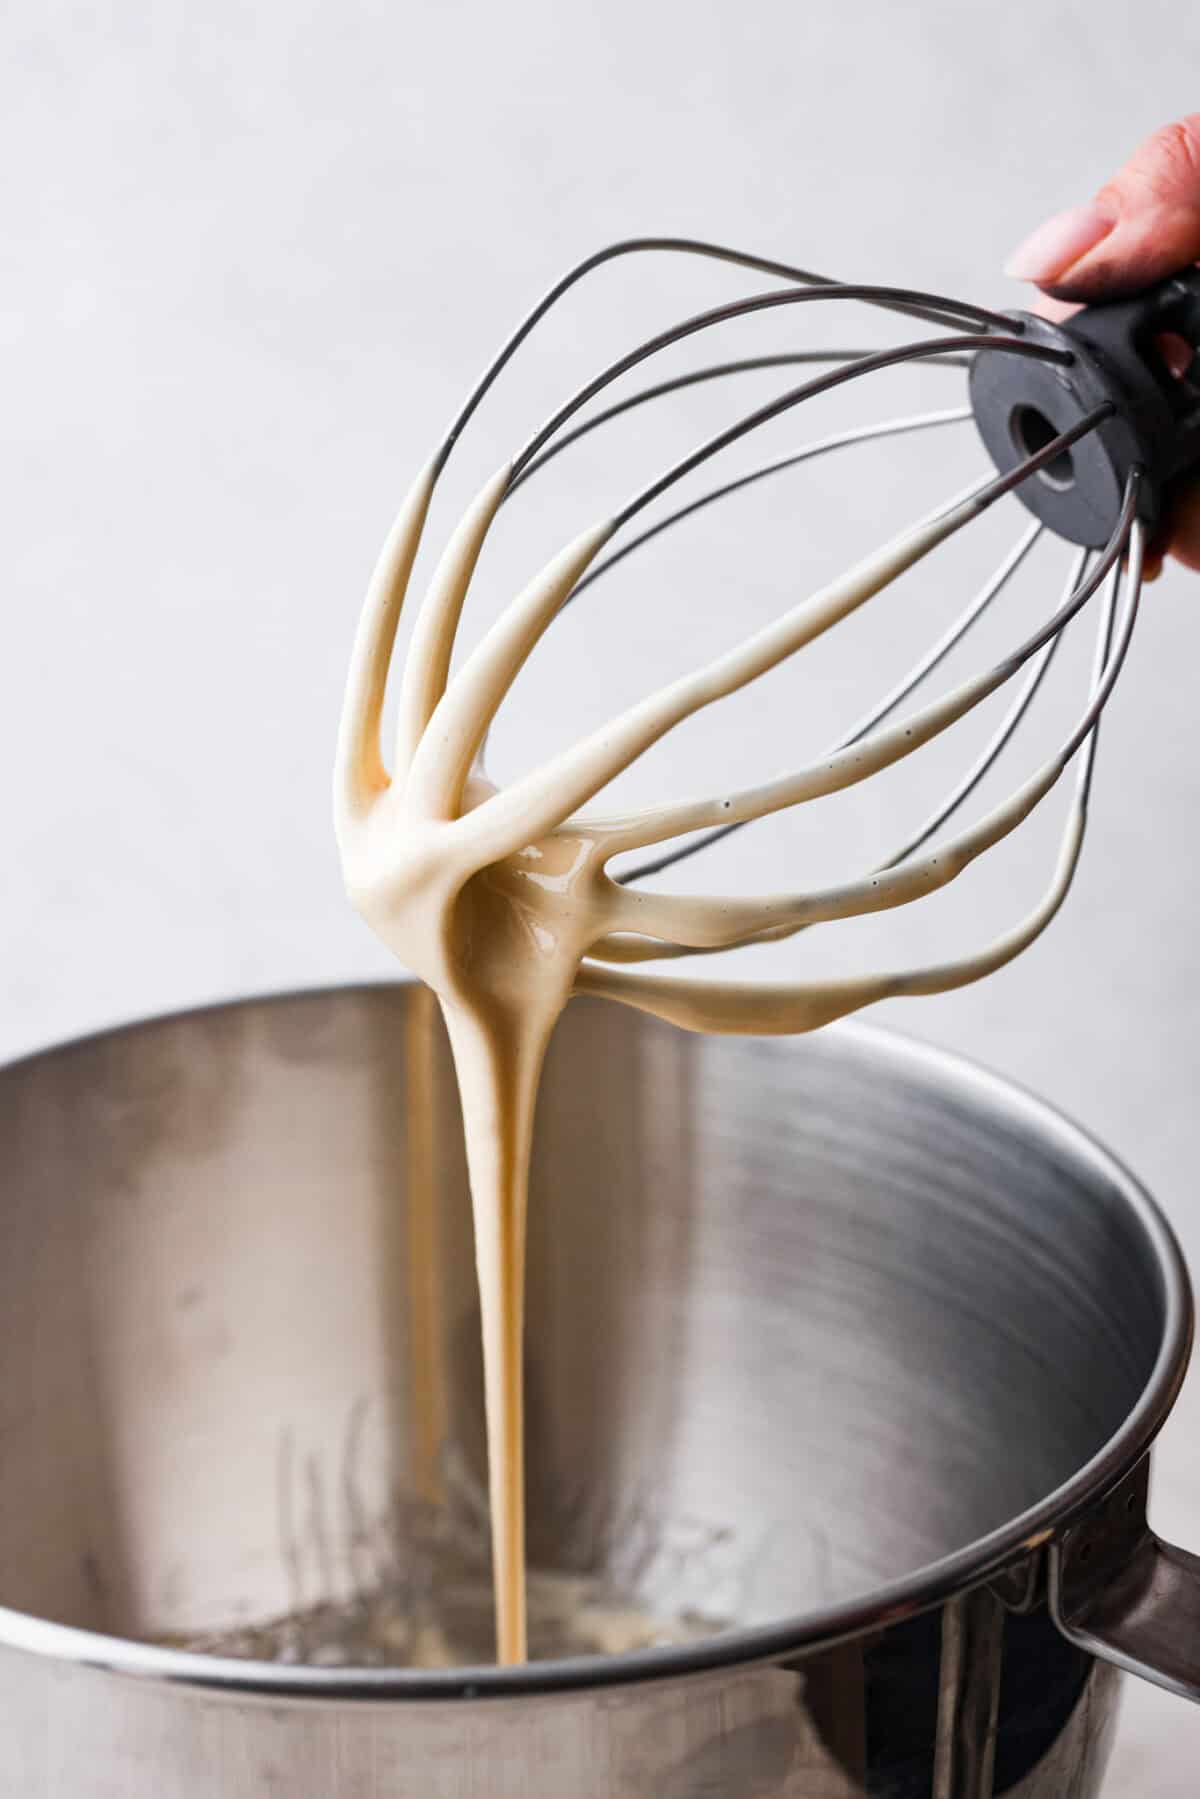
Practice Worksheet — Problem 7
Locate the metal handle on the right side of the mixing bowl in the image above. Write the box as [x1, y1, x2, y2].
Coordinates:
[1047, 1455, 1200, 1700]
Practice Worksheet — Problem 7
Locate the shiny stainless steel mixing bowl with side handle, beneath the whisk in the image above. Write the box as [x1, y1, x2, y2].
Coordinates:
[0, 986, 1200, 1799]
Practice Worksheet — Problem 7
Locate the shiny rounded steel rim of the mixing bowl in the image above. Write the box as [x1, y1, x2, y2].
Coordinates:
[0, 979, 1195, 1704]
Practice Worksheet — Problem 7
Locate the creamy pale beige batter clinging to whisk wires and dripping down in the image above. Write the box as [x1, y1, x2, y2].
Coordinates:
[335, 438, 1101, 1662]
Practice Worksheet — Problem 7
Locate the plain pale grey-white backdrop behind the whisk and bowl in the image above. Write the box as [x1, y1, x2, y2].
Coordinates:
[0, 0, 1200, 1799]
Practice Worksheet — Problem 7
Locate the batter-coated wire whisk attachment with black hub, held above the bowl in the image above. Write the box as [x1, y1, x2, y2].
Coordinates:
[336, 237, 1200, 1033]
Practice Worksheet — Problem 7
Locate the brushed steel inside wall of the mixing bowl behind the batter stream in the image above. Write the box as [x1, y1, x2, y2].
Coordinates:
[0, 988, 1166, 1639]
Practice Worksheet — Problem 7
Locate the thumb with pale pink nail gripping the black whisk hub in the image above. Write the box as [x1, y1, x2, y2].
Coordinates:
[1006, 113, 1200, 300]
